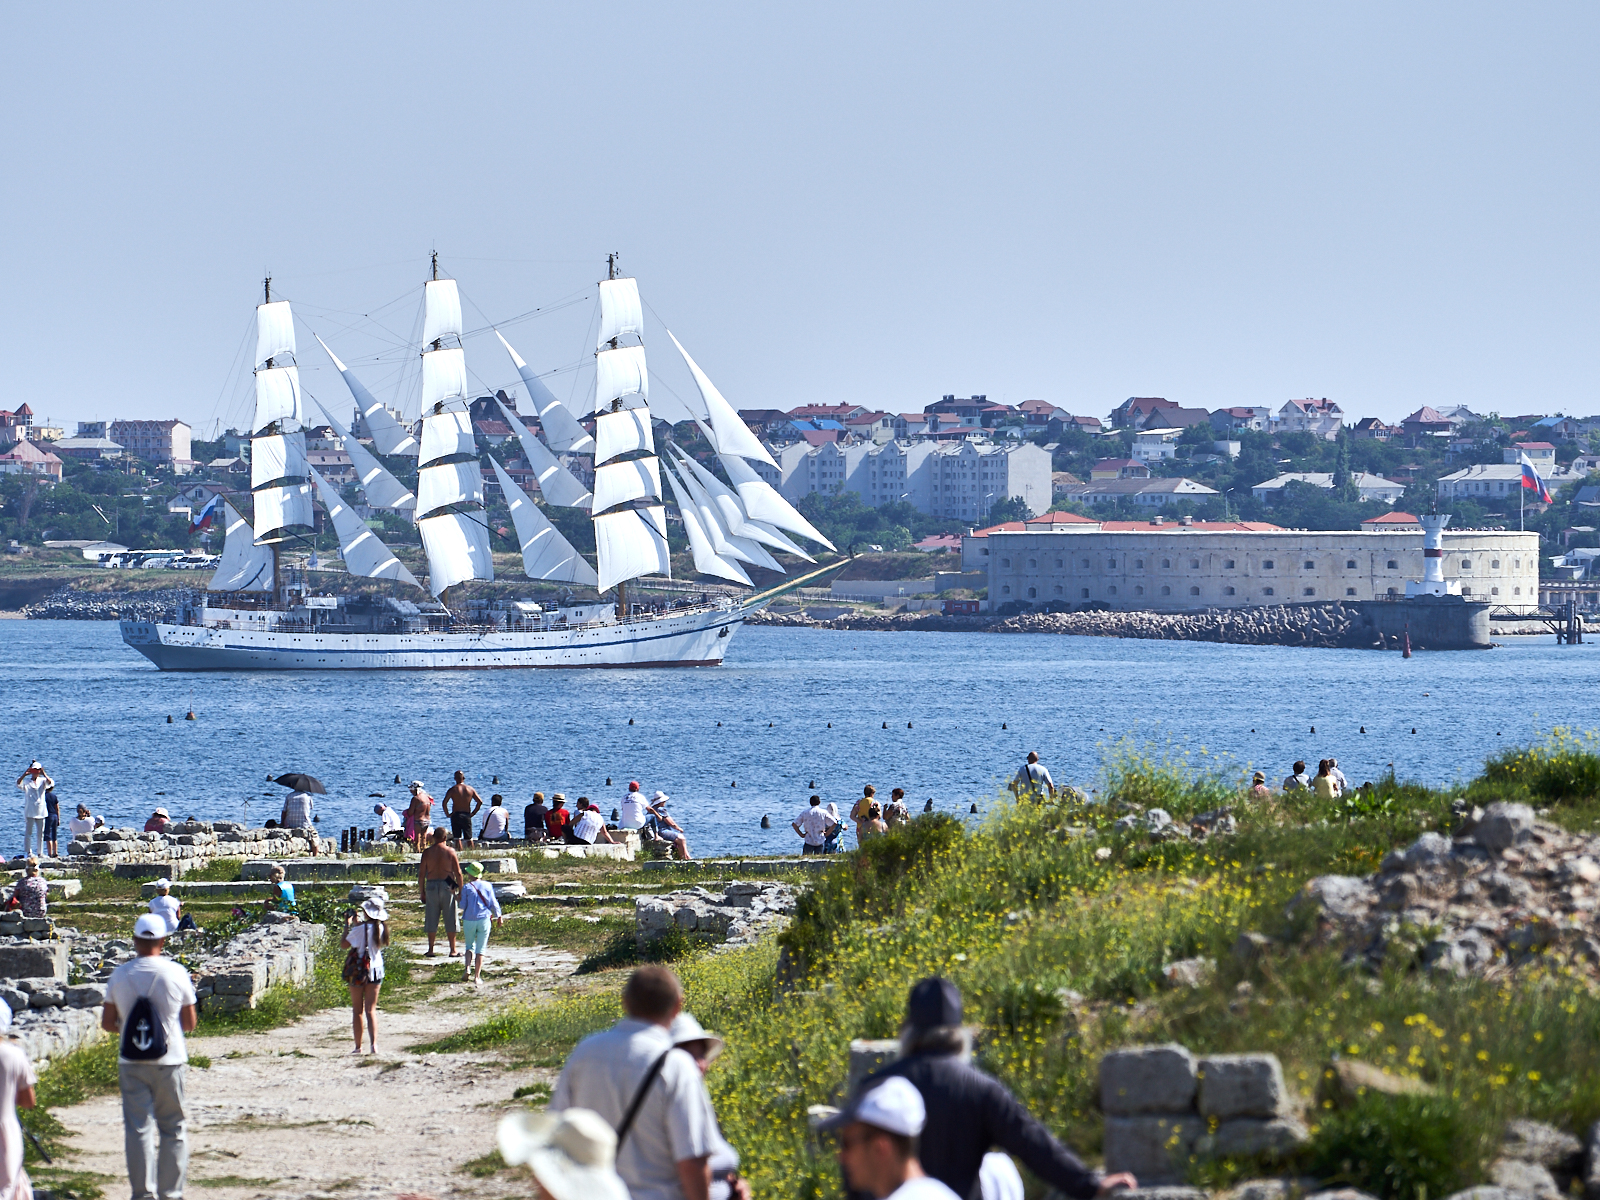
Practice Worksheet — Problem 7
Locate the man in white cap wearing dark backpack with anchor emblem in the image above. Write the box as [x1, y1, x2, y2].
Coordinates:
[101, 912, 197, 1200]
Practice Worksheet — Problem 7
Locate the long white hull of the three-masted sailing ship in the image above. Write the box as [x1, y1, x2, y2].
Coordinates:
[122, 606, 749, 670]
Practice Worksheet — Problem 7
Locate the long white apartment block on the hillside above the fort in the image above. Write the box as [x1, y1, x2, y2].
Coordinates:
[778, 440, 1053, 522]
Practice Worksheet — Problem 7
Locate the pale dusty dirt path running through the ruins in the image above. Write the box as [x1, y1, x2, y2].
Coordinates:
[46, 939, 578, 1200]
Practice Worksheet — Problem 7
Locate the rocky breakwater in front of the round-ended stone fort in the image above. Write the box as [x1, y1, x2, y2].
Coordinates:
[750, 603, 1378, 648]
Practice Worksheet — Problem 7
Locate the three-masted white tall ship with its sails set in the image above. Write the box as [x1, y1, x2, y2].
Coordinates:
[122, 254, 835, 670]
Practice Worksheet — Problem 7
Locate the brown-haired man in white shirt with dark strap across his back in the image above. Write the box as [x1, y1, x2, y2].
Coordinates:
[549, 966, 714, 1200]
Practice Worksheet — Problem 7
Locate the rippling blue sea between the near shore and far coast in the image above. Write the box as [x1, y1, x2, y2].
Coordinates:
[0, 621, 1600, 856]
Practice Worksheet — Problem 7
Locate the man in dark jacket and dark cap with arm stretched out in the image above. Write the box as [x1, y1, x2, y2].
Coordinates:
[858, 976, 1138, 1200]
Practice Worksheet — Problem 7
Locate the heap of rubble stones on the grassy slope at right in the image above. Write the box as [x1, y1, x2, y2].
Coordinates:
[1286, 802, 1600, 981]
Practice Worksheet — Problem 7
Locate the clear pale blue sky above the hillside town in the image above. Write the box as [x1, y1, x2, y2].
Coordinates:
[0, 0, 1600, 437]
